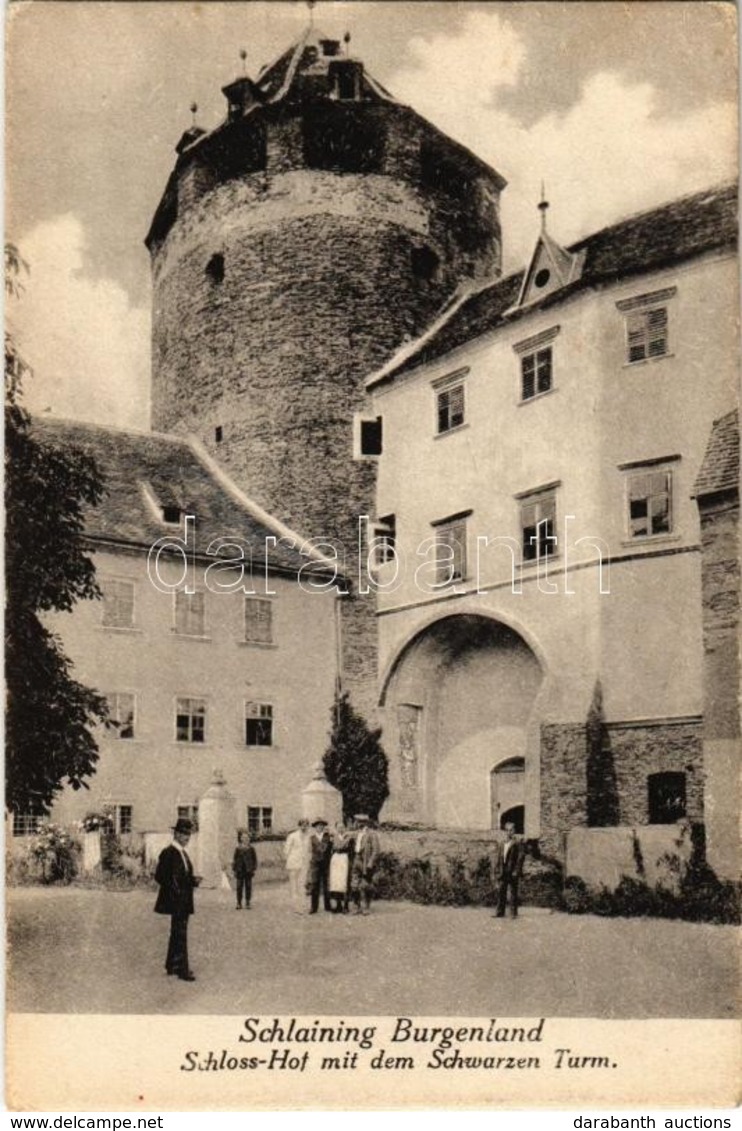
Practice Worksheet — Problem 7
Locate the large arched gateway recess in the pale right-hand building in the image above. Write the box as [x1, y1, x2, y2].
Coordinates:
[381, 613, 543, 831]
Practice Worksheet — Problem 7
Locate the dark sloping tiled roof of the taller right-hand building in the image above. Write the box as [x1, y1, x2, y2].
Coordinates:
[366, 178, 737, 388]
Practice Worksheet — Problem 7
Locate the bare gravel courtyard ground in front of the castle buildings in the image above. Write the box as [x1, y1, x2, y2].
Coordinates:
[7, 884, 737, 1018]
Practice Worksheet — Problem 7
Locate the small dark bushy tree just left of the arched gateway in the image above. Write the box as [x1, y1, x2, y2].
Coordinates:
[323, 691, 389, 820]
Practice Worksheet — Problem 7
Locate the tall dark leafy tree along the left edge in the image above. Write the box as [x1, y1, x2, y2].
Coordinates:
[5, 245, 109, 812]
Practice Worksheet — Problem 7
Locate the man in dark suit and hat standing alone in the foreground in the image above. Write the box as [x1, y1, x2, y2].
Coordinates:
[155, 817, 200, 982]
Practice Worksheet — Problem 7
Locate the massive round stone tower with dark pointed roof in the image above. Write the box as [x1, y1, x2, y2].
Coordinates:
[146, 32, 504, 710]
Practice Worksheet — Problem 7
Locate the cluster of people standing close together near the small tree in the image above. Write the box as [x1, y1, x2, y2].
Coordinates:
[284, 813, 380, 915]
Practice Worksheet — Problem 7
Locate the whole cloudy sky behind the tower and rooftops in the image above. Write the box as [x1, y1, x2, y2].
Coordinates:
[6, 0, 737, 428]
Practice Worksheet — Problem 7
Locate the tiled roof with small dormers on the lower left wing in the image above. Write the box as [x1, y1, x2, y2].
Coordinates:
[33, 416, 330, 573]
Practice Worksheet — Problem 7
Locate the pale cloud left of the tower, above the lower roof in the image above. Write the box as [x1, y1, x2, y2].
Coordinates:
[8, 214, 149, 428]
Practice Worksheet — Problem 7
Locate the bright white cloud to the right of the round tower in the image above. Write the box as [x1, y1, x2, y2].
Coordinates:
[389, 12, 737, 270]
